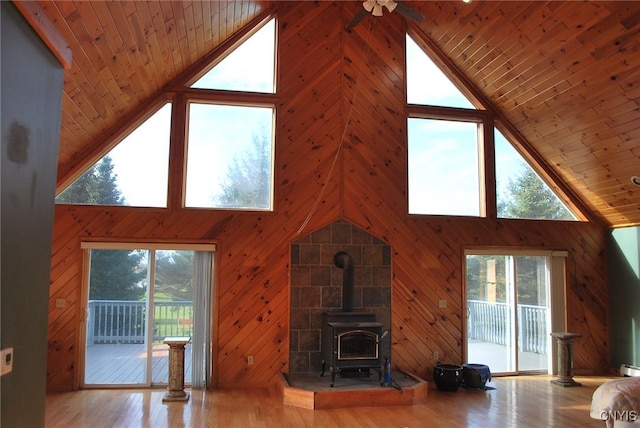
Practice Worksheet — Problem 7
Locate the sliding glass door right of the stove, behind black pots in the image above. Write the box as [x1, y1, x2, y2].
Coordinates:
[466, 253, 551, 374]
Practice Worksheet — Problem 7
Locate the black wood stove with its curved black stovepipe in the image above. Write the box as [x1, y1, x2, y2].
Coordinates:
[321, 252, 387, 386]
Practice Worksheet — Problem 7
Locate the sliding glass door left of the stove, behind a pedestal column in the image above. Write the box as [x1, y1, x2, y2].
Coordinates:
[83, 243, 213, 387]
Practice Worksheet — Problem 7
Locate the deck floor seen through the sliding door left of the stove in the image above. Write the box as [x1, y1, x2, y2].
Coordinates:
[84, 343, 191, 386]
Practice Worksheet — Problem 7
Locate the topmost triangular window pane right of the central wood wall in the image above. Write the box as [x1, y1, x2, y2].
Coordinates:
[407, 35, 475, 109]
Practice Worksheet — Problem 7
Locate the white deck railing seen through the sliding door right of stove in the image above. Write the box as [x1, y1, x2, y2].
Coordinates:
[467, 300, 549, 355]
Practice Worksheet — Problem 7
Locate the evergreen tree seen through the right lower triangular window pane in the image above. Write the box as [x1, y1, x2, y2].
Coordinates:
[498, 167, 574, 220]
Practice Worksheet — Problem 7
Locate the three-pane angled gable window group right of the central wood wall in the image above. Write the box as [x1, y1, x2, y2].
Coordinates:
[406, 35, 577, 220]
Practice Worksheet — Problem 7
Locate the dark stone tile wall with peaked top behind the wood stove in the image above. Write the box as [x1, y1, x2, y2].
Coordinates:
[289, 222, 391, 373]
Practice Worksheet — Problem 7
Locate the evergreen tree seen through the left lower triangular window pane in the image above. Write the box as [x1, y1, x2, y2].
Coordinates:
[56, 155, 126, 205]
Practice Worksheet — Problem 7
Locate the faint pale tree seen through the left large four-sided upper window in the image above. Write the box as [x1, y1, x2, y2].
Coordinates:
[214, 131, 271, 208]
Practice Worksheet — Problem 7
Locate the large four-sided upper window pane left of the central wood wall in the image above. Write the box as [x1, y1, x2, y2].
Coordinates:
[185, 103, 274, 210]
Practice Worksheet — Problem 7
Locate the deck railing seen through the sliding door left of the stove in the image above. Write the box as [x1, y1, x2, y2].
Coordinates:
[87, 300, 193, 344]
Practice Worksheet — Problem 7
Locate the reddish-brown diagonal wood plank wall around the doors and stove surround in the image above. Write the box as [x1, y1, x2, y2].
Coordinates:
[47, 2, 609, 390]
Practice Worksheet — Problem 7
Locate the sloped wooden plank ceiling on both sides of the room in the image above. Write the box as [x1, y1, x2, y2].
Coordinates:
[16, 0, 640, 227]
